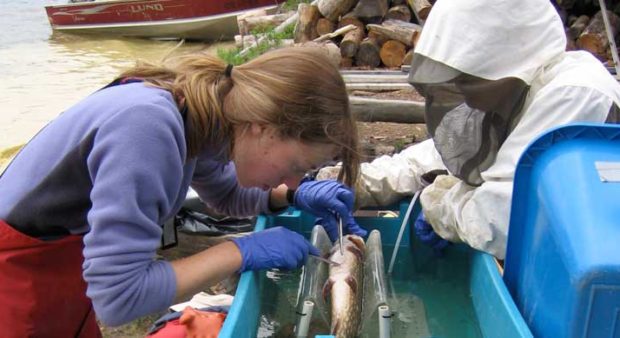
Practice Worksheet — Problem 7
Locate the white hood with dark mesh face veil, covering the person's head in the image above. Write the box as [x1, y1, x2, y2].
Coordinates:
[409, 0, 566, 186]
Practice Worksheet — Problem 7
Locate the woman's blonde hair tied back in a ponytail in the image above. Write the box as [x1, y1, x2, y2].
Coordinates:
[121, 47, 360, 186]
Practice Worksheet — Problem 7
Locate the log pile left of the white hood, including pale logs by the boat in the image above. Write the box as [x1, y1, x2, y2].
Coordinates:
[235, 0, 434, 69]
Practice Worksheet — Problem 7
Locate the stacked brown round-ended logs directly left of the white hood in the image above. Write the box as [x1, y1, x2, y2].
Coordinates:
[288, 0, 431, 69]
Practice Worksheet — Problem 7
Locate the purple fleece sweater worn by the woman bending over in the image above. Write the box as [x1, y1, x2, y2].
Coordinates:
[0, 83, 268, 325]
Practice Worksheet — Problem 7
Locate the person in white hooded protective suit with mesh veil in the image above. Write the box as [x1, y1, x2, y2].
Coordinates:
[317, 0, 620, 259]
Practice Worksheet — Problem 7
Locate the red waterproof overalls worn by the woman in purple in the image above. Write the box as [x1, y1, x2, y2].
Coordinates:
[0, 220, 101, 338]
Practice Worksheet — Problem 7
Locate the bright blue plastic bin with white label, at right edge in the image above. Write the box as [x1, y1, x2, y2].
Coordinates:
[504, 125, 620, 338]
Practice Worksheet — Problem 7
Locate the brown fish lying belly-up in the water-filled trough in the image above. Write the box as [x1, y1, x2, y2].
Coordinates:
[323, 235, 366, 338]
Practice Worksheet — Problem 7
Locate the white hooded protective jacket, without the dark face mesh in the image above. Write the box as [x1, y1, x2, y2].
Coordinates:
[318, 0, 620, 259]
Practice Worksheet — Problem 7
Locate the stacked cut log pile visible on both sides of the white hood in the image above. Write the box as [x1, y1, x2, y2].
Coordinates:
[236, 0, 620, 69]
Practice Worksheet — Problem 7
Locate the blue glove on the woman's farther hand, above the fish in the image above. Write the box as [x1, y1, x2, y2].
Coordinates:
[294, 180, 368, 242]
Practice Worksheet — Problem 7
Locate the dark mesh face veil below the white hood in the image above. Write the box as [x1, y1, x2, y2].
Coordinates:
[409, 54, 529, 186]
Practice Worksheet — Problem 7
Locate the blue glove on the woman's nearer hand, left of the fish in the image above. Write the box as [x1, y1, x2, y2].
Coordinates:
[232, 227, 320, 272]
